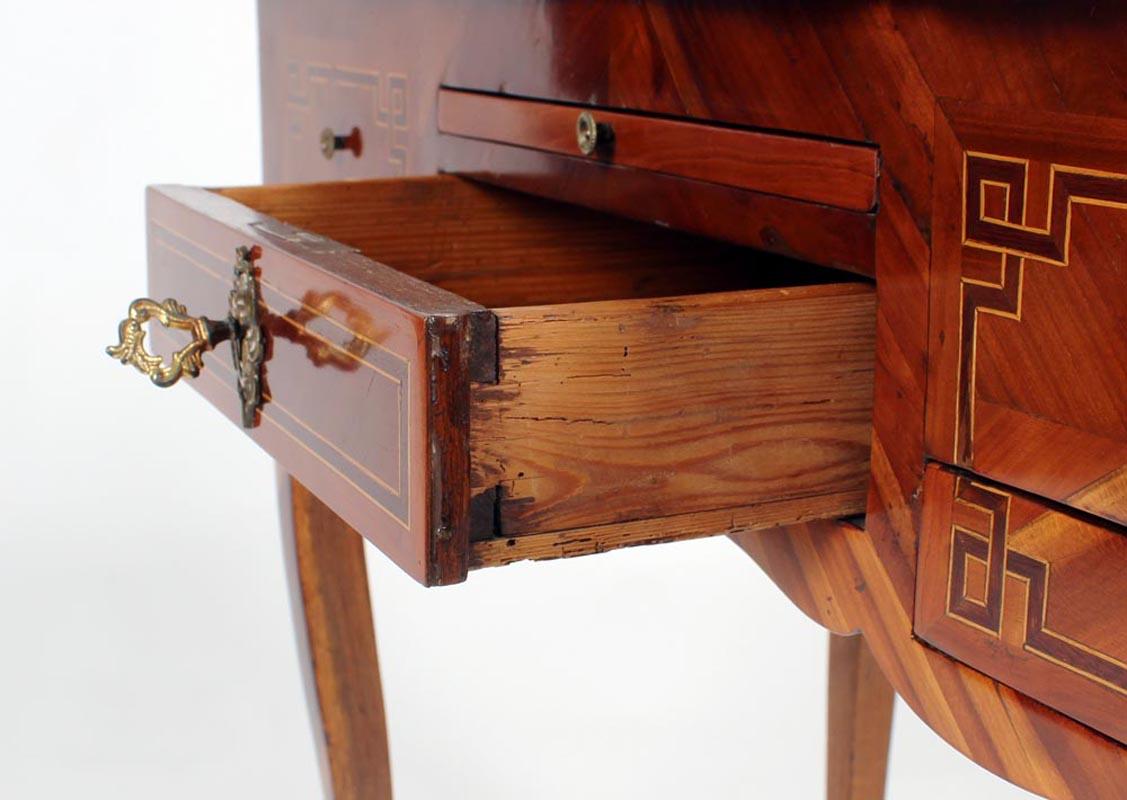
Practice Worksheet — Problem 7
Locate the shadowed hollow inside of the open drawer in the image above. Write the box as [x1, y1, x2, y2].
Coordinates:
[218, 176, 862, 309]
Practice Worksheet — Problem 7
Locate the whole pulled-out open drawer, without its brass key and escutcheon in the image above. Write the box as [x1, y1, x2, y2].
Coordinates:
[136, 176, 875, 584]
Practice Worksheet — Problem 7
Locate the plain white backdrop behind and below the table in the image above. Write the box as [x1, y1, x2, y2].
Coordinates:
[0, 0, 1028, 800]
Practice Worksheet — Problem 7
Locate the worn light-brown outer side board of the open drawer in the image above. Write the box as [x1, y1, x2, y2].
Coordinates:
[470, 283, 873, 537]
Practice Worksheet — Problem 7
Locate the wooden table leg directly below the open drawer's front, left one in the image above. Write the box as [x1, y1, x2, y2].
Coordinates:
[277, 469, 391, 800]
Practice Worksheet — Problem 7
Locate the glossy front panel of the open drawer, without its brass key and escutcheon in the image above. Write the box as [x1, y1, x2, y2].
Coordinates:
[148, 181, 488, 583]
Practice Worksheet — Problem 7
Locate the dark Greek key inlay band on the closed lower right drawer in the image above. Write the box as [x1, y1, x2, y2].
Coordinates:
[947, 478, 1127, 694]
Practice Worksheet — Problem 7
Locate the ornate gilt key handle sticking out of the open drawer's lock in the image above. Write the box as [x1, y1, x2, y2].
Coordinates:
[106, 297, 232, 388]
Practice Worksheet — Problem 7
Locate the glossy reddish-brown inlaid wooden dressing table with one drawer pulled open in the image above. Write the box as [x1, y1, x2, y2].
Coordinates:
[105, 0, 1127, 799]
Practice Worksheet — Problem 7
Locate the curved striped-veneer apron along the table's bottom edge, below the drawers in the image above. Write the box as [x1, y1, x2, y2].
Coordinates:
[733, 522, 1127, 800]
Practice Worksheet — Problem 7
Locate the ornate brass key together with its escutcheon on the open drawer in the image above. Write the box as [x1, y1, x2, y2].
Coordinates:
[106, 246, 266, 428]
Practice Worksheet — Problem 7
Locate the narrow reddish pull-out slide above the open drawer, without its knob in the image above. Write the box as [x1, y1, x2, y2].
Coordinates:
[437, 89, 879, 211]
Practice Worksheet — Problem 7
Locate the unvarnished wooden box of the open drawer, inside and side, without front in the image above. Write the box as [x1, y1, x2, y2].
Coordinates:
[216, 176, 876, 567]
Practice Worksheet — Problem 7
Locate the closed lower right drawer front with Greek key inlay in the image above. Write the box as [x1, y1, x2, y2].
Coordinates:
[915, 465, 1127, 741]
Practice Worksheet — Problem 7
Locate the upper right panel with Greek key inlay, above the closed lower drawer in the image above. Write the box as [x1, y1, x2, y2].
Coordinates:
[928, 105, 1127, 523]
